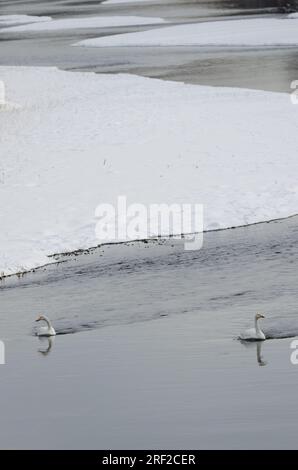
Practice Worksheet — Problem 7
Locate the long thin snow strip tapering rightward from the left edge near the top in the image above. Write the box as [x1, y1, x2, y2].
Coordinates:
[2, 16, 165, 35]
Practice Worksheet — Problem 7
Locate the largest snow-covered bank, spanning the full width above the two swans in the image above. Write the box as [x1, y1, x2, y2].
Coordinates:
[0, 67, 298, 274]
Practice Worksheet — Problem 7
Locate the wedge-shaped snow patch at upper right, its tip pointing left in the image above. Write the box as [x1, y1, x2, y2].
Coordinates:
[75, 16, 298, 47]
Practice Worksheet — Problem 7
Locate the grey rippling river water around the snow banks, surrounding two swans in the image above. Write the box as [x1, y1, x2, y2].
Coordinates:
[0, 1, 298, 449]
